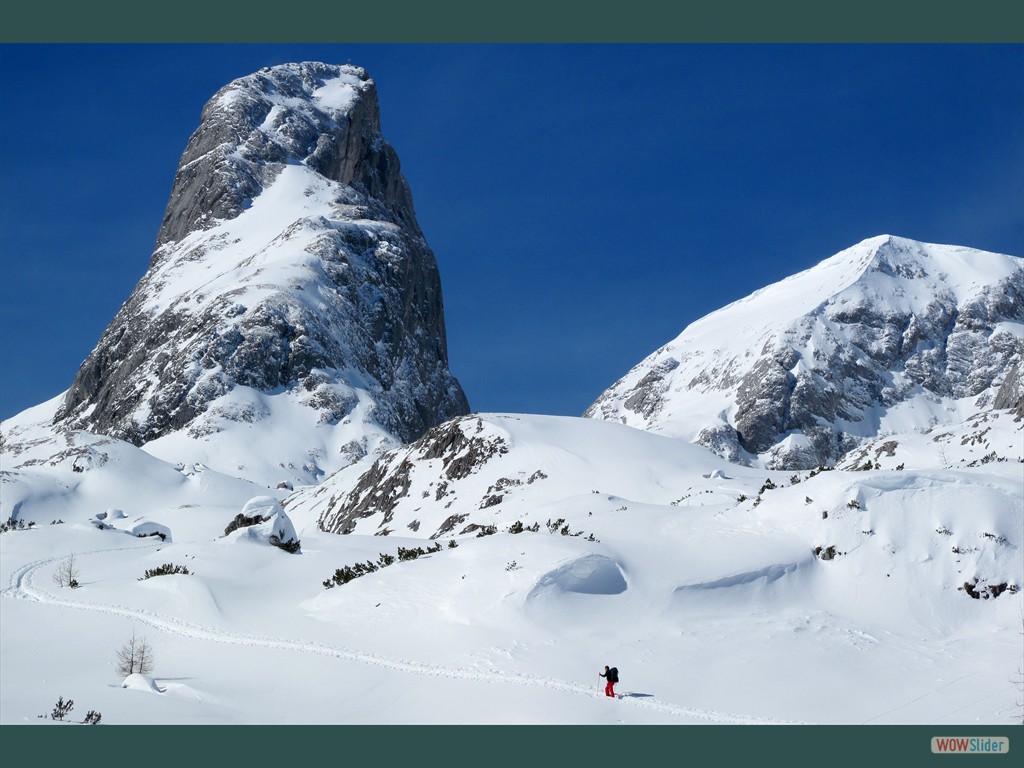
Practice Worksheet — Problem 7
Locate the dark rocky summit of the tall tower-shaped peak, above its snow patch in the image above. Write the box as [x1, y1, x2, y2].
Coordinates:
[157, 61, 416, 254]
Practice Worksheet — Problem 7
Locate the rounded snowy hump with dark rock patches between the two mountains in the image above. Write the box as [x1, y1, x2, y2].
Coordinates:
[286, 414, 755, 539]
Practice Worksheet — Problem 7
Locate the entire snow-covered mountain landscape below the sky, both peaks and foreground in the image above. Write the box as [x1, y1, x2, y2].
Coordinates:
[0, 63, 1024, 725]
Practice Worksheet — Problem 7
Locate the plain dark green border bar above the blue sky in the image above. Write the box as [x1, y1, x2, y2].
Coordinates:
[6, 0, 1024, 43]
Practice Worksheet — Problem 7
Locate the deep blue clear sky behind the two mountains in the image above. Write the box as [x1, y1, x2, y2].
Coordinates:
[0, 44, 1024, 418]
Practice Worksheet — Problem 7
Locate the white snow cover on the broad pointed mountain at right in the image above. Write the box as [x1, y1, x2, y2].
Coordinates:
[588, 234, 1024, 466]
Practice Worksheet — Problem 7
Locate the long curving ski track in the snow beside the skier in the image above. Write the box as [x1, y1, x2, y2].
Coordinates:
[2, 544, 802, 725]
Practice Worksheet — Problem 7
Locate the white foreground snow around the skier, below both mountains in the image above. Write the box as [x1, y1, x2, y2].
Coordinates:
[0, 411, 1024, 725]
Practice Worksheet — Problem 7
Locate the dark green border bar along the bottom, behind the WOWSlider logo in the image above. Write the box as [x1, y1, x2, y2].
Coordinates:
[0, 729, 1024, 768]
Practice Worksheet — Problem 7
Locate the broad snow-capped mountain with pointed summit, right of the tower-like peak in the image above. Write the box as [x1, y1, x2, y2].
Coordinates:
[586, 236, 1024, 469]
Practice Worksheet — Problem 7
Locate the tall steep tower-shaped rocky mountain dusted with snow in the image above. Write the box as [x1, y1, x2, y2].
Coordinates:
[45, 62, 468, 482]
